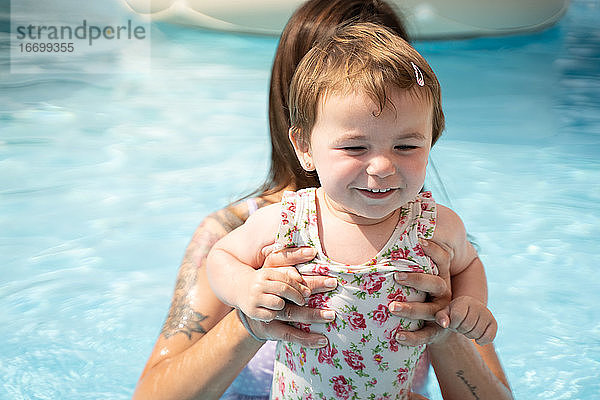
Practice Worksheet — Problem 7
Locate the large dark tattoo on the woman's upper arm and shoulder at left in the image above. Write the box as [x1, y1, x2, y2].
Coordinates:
[161, 209, 244, 340]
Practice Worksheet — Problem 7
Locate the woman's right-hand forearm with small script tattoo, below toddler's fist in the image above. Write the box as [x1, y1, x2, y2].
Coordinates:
[428, 332, 513, 400]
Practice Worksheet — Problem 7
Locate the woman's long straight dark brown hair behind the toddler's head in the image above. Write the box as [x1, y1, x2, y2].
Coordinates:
[254, 0, 408, 195]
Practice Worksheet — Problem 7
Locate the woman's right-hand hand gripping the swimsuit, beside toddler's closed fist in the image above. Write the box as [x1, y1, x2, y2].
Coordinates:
[389, 240, 453, 346]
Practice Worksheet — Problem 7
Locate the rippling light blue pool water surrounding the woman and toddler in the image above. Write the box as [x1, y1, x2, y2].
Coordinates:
[0, 0, 600, 400]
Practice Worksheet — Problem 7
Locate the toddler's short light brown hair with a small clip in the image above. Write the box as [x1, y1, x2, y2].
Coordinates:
[289, 23, 444, 145]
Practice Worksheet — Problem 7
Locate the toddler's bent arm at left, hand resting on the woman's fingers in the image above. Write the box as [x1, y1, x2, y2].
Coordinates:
[207, 204, 310, 321]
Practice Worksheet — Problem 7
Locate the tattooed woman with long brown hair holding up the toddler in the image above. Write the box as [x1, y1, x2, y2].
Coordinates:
[134, 0, 511, 399]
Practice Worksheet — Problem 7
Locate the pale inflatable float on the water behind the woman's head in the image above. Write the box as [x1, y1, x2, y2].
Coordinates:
[122, 0, 569, 39]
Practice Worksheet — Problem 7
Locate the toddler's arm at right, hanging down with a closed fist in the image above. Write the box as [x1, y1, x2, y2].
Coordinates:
[434, 205, 498, 345]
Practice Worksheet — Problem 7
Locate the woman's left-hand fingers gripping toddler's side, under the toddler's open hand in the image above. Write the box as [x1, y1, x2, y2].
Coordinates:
[248, 247, 337, 348]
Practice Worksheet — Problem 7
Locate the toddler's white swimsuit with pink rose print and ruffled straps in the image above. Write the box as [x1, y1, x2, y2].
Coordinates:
[271, 188, 437, 400]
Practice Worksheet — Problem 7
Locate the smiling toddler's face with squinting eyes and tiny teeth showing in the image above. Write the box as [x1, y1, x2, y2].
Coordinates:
[297, 88, 432, 223]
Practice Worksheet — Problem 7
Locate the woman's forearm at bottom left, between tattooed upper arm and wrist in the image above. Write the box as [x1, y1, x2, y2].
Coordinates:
[133, 312, 262, 400]
